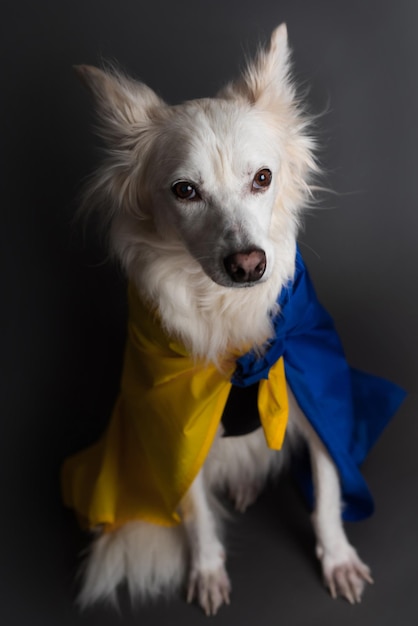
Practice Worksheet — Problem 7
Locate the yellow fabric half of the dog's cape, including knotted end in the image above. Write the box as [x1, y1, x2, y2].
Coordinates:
[62, 287, 288, 530]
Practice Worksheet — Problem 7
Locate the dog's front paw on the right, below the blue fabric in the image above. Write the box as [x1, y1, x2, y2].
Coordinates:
[317, 544, 373, 604]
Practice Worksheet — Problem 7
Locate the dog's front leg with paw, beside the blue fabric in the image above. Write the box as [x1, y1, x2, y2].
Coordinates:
[289, 394, 373, 604]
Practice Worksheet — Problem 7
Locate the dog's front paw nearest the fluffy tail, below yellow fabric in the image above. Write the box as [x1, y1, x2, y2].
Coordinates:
[187, 565, 231, 615]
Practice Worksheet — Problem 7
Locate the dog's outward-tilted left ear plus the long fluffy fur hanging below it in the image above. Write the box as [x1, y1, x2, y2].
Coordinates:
[74, 65, 170, 221]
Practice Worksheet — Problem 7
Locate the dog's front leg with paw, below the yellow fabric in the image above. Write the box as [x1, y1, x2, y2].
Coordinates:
[181, 472, 231, 615]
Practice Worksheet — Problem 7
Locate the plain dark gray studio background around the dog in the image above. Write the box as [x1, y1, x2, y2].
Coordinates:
[0, 0, 418, 626]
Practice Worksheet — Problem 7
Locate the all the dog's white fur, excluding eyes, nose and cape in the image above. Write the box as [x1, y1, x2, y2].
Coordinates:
[73, 25, 370, 614]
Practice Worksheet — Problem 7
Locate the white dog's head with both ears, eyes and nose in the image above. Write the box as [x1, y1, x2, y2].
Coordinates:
[77, 25, 315, 287]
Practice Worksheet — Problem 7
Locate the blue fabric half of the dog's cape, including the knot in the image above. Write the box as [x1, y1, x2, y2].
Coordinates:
[232, 250, 406, 521]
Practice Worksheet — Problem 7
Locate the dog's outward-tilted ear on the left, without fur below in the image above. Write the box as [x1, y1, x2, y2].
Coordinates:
[74, 65, 168, 145]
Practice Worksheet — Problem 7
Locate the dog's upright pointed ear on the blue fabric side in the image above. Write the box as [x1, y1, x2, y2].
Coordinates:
[220, 24, 294, 108]
